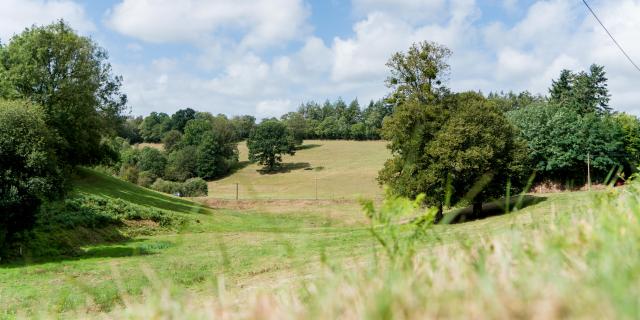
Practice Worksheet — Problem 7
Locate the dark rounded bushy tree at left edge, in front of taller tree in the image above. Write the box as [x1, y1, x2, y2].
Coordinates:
[0, 100, 64, 245]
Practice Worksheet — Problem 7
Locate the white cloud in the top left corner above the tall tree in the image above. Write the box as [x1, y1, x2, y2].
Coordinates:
[0, 0, 95, 43]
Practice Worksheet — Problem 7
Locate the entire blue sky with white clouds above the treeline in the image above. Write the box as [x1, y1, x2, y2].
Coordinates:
[0, 0, 640, 119]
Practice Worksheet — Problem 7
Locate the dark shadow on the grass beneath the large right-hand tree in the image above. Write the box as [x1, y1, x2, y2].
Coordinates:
[444, 195, 547, 224]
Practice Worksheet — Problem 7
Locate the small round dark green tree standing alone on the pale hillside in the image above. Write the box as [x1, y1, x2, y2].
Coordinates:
[247, 120, 295, 171]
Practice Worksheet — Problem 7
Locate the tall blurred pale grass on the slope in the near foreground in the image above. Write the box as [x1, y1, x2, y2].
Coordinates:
[96, 182, 640, 319]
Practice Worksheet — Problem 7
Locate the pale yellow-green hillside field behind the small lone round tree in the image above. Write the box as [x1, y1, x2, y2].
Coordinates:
[209, 140, 389, 199]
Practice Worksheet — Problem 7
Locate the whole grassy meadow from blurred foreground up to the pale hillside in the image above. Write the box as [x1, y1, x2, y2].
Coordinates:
[0, 141, 640, 319]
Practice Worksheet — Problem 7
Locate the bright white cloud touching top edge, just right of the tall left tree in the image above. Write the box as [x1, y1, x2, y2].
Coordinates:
[107, 0, 309, 47]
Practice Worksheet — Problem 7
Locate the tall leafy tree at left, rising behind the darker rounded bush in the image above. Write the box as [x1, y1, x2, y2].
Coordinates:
[0, 21, 127, 166]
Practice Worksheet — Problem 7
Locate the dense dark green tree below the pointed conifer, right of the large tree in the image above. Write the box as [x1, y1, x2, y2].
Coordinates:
[508, 104, 624, 183]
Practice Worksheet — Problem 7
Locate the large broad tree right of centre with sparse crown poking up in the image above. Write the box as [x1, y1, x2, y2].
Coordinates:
[378, 42, 518, 217]
